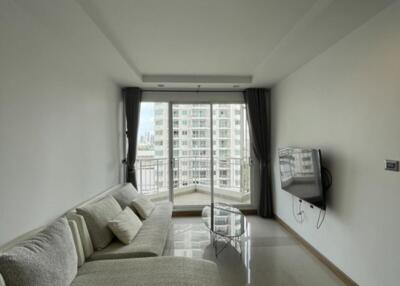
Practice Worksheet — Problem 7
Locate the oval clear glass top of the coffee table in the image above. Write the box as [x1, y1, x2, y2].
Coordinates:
[202, 203, 246, 238]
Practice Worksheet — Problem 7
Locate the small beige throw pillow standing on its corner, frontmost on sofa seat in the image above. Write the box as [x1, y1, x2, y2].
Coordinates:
[108, 207, 143, 244]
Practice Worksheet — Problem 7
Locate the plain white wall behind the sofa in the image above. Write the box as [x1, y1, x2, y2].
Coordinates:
[0, 0, 122, 245]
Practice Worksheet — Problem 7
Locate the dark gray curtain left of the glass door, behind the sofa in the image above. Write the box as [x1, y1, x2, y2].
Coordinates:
[122, 87, 142, 188]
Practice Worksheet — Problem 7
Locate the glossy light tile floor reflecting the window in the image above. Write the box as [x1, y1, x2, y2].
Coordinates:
[164, 216, 344, 286]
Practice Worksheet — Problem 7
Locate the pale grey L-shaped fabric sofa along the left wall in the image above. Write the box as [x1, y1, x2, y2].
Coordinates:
[0, 185, 220, 286]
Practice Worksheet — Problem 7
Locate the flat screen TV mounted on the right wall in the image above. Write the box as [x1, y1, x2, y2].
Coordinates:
[278, 148, 326, 210]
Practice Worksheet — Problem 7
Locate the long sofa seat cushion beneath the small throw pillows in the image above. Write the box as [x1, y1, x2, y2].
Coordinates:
[90, 202, 172, 260]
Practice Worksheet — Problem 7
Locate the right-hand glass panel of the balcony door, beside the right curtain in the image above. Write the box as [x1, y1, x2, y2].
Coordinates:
[212, 104, 250, 205]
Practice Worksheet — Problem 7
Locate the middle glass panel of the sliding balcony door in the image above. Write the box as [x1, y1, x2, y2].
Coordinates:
[172, 104, 212, 206]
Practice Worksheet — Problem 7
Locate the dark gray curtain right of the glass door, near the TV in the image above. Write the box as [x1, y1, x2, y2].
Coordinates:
[243, 88, 273, 218]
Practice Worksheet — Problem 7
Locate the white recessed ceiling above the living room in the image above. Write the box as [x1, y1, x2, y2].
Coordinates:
[16, 0, 393, 89]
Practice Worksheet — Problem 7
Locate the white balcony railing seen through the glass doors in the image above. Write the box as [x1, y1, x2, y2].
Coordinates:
[135, 156, 250, 202]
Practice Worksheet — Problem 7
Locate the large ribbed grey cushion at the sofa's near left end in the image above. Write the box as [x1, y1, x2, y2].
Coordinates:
[0, 218, 78, 286]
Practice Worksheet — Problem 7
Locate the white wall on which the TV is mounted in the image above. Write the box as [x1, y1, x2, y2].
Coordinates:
[272, 1, 400, 285]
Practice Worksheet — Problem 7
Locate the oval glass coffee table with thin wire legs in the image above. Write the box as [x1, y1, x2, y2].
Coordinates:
[202, 203, 247, 256]
